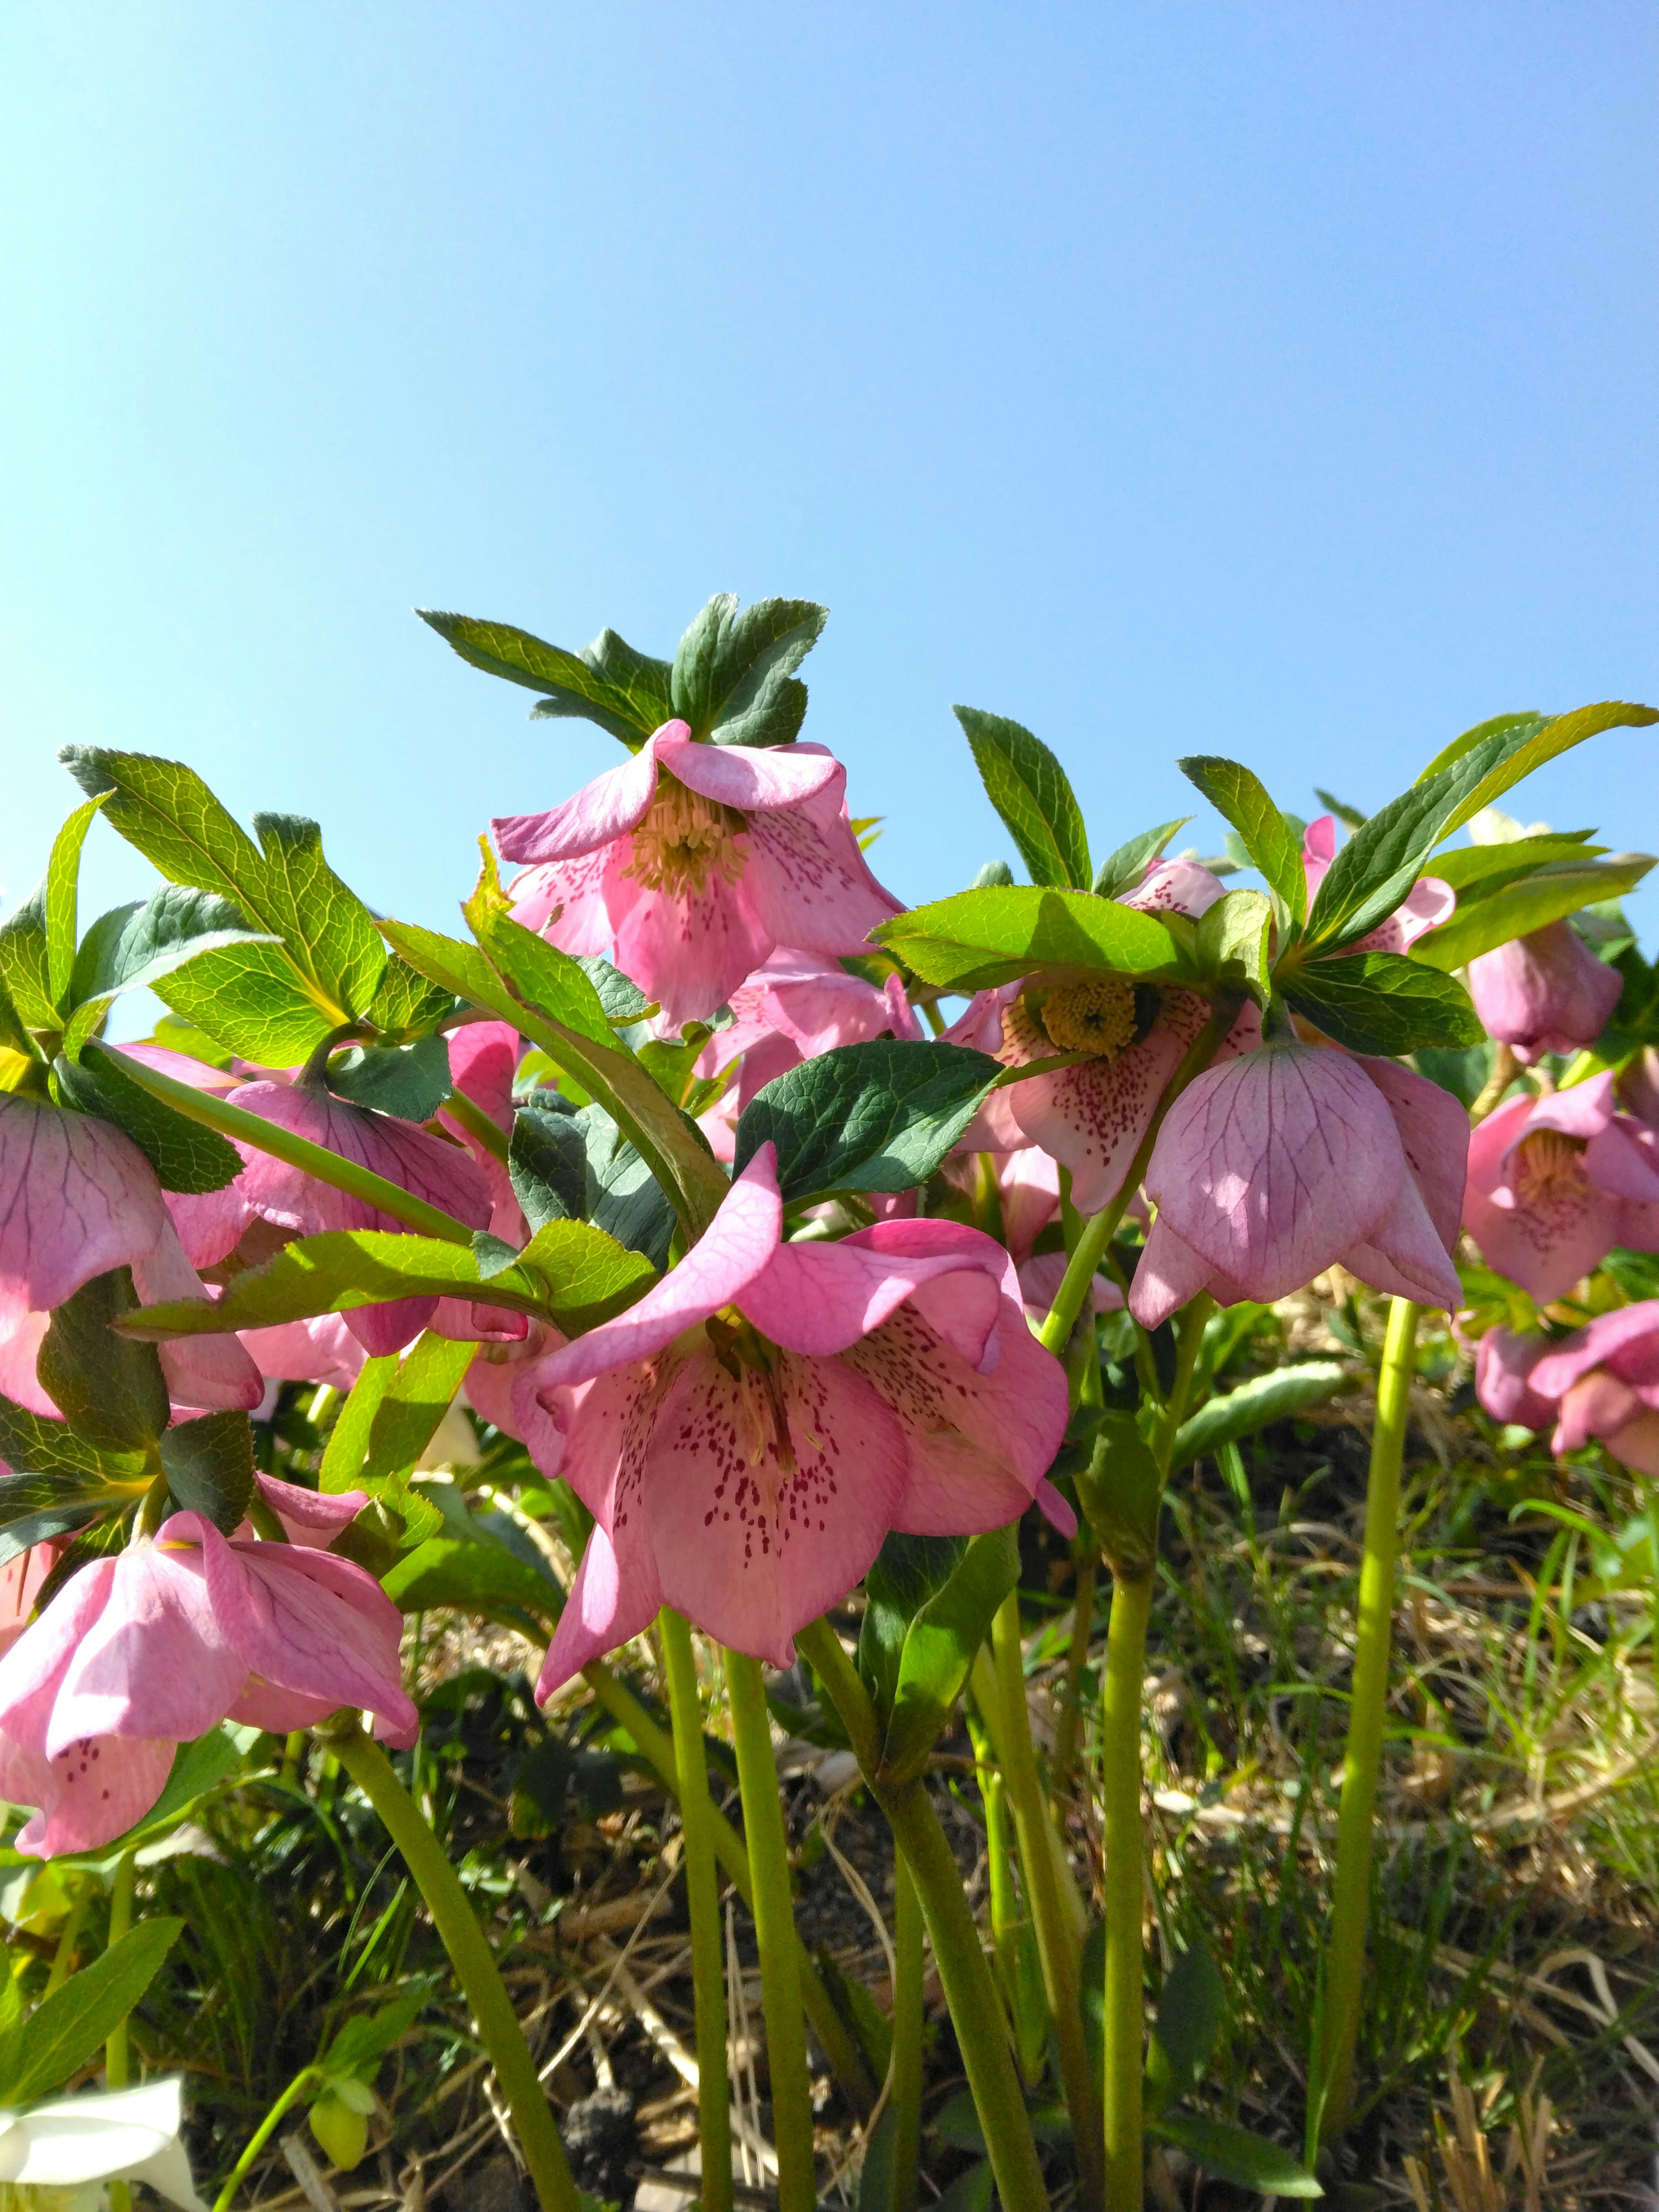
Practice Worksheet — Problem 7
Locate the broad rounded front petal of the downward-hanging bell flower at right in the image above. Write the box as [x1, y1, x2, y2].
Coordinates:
[1130, 1044, 1407, 1319]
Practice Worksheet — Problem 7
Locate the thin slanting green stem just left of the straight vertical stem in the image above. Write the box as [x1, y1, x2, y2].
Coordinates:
[991, 1590, 1102, 2212]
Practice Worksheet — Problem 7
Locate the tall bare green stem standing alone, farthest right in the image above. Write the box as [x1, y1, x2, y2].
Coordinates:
[1307, 1298, 1418, 2141]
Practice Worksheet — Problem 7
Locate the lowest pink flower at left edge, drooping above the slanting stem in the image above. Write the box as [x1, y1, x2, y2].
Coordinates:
[0, 1475, 418, 1858]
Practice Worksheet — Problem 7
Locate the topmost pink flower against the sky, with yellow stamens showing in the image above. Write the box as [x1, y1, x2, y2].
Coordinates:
[493, 721, 900, 1029]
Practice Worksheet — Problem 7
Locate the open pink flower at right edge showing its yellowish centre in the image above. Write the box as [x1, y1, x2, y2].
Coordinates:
[1462, 1073, 1659, 1305]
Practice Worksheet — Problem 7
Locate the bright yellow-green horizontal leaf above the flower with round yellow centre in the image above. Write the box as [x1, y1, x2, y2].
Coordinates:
[871, 883, 1192, 991]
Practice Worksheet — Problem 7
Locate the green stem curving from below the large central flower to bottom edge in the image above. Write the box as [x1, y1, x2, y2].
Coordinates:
[794, 1621, 1049, 2212]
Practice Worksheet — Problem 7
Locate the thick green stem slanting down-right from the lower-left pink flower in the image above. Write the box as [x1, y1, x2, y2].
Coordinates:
[330, 1730, 582, 2212]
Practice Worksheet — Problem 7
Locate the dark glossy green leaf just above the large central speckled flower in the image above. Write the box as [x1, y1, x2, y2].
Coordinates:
[732, 1037, 1002, 1201]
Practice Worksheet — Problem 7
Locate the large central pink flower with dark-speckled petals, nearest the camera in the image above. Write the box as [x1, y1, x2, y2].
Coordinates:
[533, 1146, 1071, 1697]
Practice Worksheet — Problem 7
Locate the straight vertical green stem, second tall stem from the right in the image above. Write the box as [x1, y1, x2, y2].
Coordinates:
[1100, 1562, 1153, 2212]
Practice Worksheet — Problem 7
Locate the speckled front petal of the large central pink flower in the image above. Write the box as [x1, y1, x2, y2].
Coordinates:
[650, 1351, 905, 1665]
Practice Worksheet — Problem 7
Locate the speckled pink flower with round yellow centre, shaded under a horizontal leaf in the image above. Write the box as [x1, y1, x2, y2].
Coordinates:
[944, 861, 1221, 1214]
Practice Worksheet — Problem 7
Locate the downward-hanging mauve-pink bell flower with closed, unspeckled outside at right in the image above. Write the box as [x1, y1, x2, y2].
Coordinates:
[1128, 1044, 1469, 1329]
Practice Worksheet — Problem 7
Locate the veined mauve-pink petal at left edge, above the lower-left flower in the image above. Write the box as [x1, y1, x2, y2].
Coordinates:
[0, 1090, 166, 1309]
